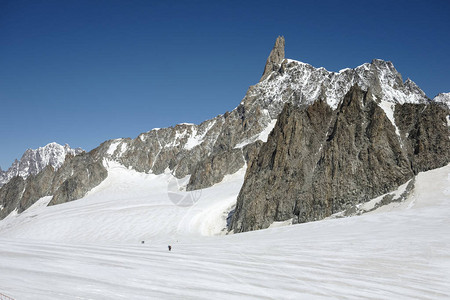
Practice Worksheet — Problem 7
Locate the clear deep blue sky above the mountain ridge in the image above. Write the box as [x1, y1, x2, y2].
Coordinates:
[0, 0, 450, 169]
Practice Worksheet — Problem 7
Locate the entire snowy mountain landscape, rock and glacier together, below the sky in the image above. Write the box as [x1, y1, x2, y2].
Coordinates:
[0, 37, 450, 299]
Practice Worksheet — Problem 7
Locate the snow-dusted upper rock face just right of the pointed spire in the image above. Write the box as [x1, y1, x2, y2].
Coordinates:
[251, 54, 428, 113]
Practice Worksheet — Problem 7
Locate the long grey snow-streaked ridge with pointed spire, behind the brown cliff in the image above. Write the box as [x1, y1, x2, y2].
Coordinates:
[0, 37, 442, 217]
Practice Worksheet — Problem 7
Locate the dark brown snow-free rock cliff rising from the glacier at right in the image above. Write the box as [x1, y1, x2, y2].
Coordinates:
[230, 86, 450, 232]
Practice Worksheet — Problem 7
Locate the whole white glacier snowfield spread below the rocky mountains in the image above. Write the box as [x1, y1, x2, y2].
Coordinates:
[0, 163, 450, 299]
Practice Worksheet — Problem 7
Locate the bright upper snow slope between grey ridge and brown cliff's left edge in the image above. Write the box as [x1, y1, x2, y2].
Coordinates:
[0, 161, 245, 243]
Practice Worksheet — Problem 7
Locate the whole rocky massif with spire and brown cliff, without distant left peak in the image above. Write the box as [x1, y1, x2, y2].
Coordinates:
[0, 37, 449, 232]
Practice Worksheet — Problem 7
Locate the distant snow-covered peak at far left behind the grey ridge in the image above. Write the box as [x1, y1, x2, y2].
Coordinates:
[0, 143, 83, 187]
